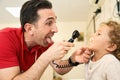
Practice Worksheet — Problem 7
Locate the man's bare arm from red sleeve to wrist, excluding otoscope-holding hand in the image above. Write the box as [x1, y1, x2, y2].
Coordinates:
[0, 55, 50, 80]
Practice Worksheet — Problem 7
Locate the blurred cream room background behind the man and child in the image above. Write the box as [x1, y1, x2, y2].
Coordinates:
[0, 0, 120, 80]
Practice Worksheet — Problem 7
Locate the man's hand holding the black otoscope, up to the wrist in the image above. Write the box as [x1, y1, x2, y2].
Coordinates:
[43, 41, 74, 61]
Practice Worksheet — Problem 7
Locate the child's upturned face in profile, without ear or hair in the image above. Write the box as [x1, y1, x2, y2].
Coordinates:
[90, 25, 110, 51]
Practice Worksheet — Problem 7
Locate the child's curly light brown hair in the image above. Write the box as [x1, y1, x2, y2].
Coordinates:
[102, 21, 120, 61]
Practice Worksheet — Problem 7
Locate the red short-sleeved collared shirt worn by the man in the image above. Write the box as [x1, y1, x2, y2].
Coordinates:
[0, 28, 48, 71]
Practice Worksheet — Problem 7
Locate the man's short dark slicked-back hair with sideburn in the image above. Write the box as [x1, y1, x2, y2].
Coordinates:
[20, 0, 52, 31]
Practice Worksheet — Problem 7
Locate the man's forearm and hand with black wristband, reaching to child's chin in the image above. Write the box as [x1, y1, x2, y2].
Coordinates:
[51, 47, 91, 75]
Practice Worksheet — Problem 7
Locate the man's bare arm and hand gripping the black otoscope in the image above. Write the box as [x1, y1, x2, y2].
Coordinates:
[0, 42, 73, 80]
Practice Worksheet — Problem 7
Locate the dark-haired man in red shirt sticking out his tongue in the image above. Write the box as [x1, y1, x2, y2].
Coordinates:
[0, 0, 90, 80]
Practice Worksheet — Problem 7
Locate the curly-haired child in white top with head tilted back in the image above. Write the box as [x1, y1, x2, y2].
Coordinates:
[85, 21, 120, 80]
